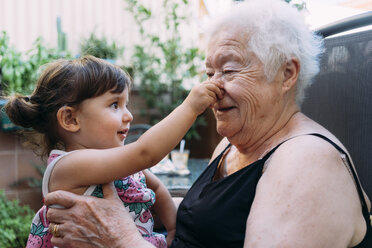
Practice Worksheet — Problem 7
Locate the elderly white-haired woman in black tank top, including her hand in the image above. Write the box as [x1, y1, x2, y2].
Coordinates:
[46, 0, 372, 247]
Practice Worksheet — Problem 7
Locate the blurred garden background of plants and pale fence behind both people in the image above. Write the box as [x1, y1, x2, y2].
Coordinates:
[0, 0, 372, 247]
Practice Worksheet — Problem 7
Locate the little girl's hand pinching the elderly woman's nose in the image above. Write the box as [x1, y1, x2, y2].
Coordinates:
[184, 80, 223, 115]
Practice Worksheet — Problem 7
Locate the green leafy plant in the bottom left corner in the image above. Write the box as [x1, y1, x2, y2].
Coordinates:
[0, 190, 35, 248]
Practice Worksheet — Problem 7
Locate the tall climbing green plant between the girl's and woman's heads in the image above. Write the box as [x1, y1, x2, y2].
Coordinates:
[125, 0, 206, 140]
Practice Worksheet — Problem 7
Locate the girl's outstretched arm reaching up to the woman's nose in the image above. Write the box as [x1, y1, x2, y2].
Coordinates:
[49, 81, 222, 191]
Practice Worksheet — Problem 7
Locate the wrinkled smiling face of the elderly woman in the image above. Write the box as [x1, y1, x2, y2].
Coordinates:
[206, 28, 280, 142]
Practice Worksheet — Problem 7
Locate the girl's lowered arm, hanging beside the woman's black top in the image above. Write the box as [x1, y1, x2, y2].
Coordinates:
[143, 170, 177, 247]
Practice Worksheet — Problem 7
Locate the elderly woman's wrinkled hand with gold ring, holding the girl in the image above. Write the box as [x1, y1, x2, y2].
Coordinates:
[45, 184, 153, 248]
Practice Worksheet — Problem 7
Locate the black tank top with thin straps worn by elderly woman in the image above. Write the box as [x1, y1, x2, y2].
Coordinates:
[171, 134, 372, 248]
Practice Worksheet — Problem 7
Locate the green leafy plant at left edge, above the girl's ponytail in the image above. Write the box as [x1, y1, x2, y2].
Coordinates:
[0, 31, 71, 95]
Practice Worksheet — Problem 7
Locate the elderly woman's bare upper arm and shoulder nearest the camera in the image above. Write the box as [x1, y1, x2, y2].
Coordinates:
[244, 136, 360, 248]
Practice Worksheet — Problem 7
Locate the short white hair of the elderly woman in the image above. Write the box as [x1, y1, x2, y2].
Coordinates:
[208, 0, 324, 105]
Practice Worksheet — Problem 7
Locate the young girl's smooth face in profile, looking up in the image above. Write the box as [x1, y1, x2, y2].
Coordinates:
[78, 90, 133, 149]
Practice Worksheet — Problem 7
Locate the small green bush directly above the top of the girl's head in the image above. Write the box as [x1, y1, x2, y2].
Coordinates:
[80, 33, 123, 59]
